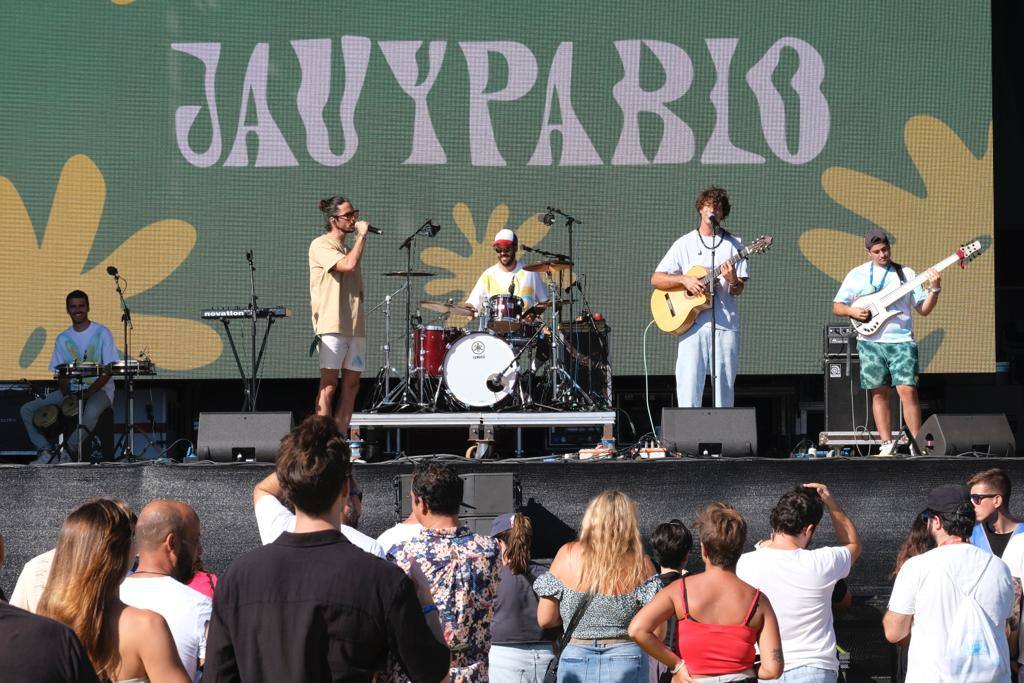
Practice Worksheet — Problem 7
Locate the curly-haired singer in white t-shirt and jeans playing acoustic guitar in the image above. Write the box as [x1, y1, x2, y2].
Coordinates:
[650, 186, 748, 408]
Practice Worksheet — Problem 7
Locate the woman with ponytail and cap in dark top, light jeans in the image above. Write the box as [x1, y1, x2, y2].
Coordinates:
[487, 512, 558, 683]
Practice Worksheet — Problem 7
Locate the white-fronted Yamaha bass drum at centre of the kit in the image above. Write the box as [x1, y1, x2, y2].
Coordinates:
[441, 332, 519, 408]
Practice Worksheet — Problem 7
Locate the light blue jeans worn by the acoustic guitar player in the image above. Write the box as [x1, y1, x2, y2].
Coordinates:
[676, 324, 739, 408]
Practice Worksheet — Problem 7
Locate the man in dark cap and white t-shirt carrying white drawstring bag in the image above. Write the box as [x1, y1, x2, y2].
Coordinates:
[882, 484, 1014, 683]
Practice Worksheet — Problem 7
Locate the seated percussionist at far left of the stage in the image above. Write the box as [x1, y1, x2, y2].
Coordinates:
[22, 290, 120, 465]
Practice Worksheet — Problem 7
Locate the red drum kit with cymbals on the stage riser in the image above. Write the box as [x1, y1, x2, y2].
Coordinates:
[371, 258, 604, 412]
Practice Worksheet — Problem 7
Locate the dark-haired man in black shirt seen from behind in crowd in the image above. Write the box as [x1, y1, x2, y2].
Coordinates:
[203, 416, 449, 683]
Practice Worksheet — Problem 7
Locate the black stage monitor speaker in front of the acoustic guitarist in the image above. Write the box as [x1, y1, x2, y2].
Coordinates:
[662, 408, 758, 458]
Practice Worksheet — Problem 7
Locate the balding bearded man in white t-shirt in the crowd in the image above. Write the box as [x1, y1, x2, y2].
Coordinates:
[121, 500, 213, 680]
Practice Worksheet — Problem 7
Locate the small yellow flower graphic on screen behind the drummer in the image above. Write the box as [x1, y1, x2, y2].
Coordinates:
[420, 202, 550, 325]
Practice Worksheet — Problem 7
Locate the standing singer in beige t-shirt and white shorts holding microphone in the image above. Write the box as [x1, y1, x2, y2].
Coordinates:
[309, 196, 380, 434]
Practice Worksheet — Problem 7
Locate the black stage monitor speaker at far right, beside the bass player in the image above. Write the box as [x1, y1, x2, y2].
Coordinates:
[916, 414, 1017, 458]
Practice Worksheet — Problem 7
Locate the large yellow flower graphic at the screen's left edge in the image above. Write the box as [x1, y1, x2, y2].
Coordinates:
[0, 155, 221, 379]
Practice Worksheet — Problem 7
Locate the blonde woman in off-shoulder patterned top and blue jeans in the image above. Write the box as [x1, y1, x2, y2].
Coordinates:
[534, 490, 662, 683]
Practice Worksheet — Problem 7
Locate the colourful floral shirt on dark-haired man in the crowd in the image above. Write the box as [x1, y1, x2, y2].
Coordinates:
[388, 526, 502, 683]
